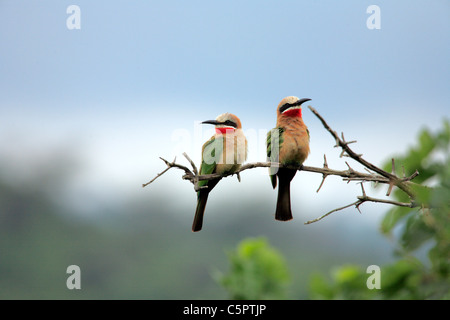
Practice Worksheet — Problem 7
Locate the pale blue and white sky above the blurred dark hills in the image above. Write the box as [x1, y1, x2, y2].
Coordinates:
[0, 0, 450, 219]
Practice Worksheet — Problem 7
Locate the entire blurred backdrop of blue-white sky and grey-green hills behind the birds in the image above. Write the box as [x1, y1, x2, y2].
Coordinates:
[0, 0, 450, 299]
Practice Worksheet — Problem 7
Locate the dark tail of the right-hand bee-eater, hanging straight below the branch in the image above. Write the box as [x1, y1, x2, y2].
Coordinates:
[275, 168, 297, 221]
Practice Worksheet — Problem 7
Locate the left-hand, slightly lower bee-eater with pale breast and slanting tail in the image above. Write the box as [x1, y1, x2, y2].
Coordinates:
[192, 113, 247, 232]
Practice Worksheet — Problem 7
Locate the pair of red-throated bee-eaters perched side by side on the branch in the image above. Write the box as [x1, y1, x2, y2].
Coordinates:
[192, 96, 311, 232]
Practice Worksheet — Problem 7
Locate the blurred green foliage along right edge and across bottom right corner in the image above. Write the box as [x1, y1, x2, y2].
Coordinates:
[310, 121, 450, 299]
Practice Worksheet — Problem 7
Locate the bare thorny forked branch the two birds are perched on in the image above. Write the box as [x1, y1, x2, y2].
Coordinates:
[142, 106, 420, 224]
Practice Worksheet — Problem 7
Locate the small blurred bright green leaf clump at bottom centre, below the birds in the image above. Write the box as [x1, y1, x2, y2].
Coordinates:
[216, 238, 289, 300]
